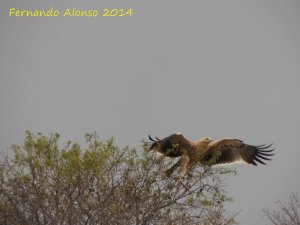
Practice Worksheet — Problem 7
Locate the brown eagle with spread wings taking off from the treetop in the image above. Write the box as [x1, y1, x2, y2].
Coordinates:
[149, 132, 275, 181]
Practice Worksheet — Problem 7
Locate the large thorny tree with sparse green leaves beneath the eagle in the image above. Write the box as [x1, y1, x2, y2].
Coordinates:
[0, 131, 235, 225]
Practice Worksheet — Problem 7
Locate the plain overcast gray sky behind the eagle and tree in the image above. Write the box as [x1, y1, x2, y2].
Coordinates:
[0, 0, 300, 225]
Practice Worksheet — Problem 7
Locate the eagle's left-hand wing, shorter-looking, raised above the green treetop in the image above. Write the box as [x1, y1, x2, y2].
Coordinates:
[149, 133, 192, 158]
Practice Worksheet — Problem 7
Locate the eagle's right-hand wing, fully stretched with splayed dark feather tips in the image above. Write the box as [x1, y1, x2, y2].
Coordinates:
[203, 139, 274, 166]
